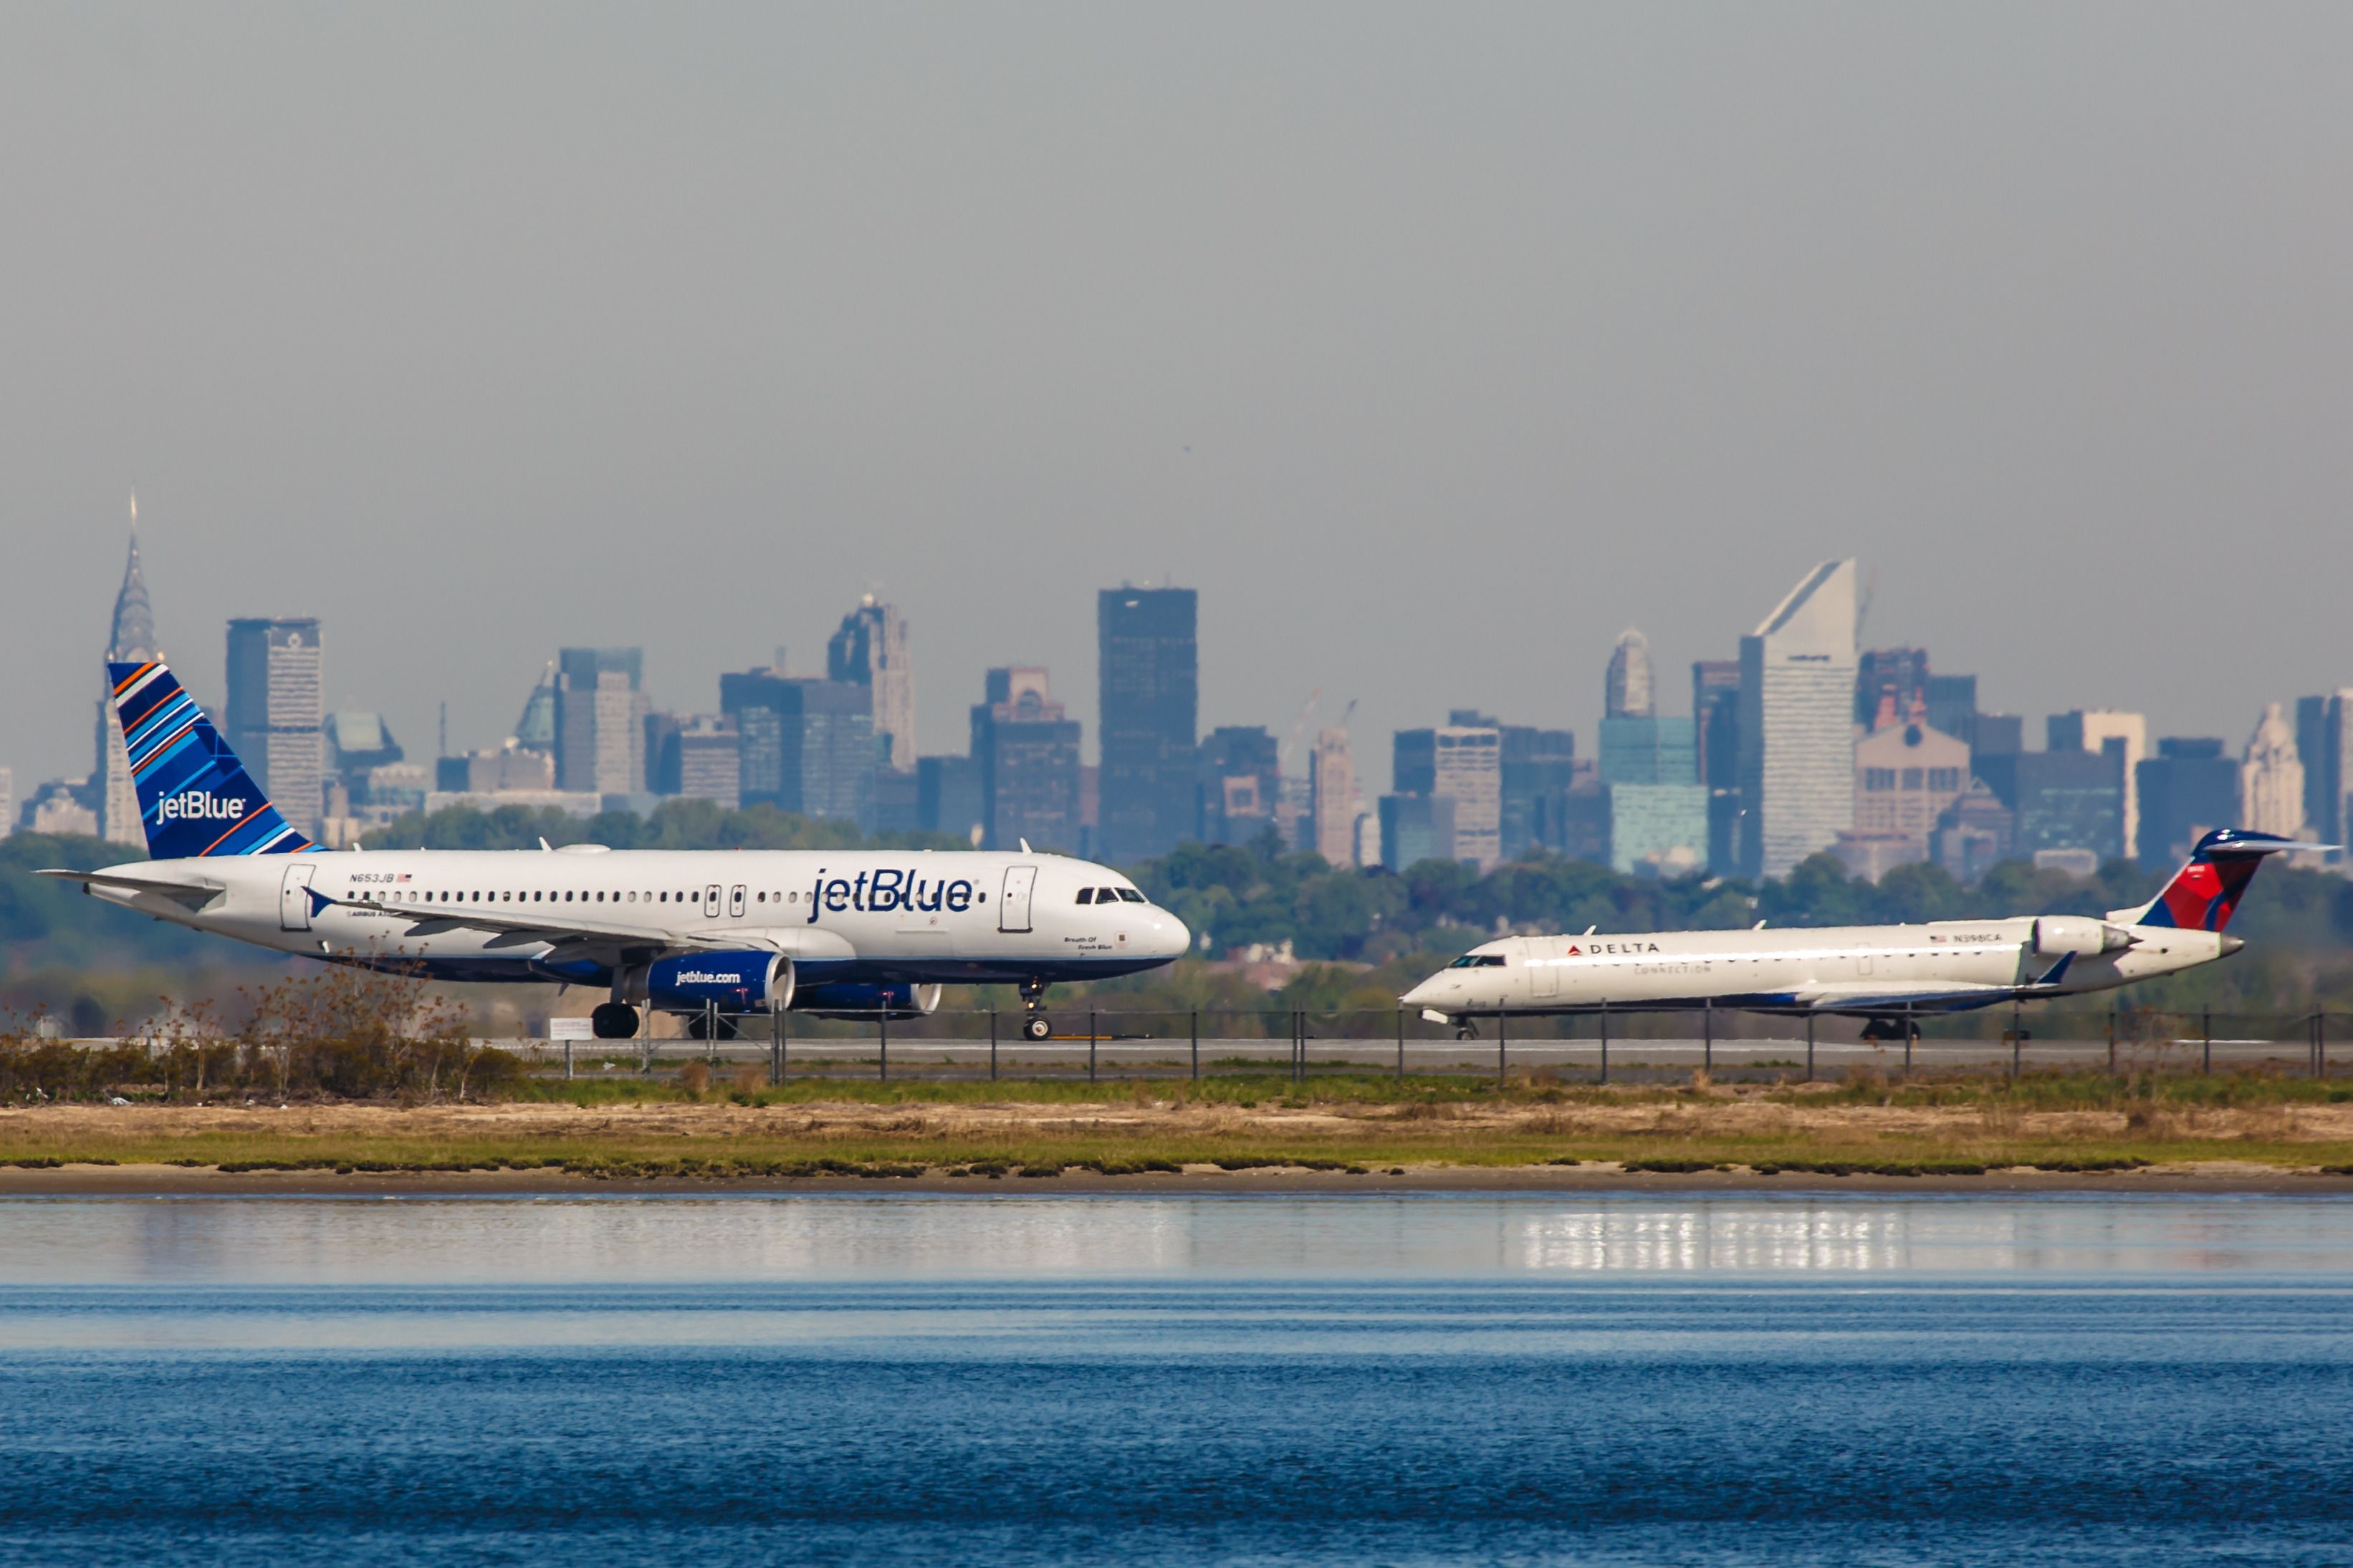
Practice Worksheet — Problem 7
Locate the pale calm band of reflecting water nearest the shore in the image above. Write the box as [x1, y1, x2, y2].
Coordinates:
[0, 1194, 2353, 1286]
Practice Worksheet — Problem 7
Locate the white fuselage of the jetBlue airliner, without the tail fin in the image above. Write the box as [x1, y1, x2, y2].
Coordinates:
[92, 846, 1191, 983]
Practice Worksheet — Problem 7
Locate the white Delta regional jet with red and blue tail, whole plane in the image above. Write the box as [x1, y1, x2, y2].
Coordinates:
[1402, 827, 2325, 1039]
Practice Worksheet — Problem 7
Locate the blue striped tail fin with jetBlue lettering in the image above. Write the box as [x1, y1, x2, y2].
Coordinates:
[106, 660, 310, 860]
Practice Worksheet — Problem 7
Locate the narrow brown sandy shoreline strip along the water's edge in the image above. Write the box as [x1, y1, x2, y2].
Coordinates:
[0, 1161, 2353, 1199]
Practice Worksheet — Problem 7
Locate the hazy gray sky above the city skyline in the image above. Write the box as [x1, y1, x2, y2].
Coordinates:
[0, 0, 2353, 790]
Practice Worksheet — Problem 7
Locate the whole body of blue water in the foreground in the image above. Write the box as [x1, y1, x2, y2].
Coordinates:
[0, 1194, 2353, 1568]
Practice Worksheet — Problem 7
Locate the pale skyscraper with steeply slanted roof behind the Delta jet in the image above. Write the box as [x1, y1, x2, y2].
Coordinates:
[1739, 559, 1854, 877]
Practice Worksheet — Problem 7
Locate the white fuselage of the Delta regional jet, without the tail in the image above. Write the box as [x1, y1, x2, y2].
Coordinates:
[1405, 917, 2238, 1016]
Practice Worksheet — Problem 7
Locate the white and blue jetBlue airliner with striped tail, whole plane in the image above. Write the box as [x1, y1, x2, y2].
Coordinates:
[40, 663, 1191, 1039]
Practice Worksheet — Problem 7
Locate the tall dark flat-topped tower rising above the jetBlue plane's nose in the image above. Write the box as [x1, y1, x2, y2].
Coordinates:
[1094, 587, 1200, 862]
